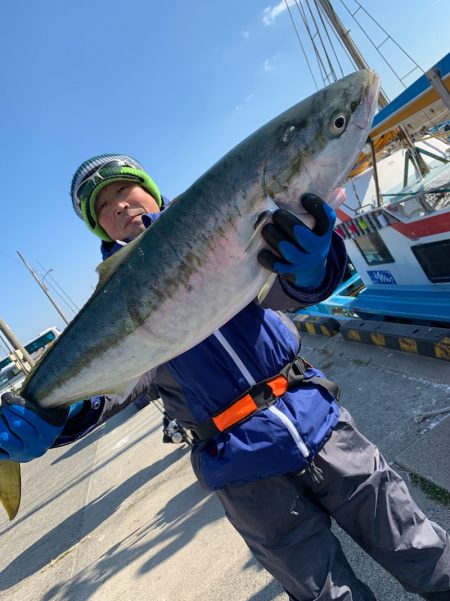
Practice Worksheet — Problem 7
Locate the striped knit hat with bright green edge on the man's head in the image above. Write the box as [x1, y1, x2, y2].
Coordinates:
[70, 154, 162, 242]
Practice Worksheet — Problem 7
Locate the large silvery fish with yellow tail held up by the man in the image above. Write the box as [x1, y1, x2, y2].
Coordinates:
[0, 70, 378, 519]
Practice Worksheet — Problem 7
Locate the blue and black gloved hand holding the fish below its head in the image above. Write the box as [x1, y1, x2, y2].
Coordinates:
[258, 194, 336, 291]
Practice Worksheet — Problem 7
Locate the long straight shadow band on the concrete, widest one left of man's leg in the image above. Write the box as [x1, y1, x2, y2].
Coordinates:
[0, 448, 189, 590]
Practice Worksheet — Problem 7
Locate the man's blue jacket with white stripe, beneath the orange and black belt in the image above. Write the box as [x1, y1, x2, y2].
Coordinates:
[55, 206, 346, 490]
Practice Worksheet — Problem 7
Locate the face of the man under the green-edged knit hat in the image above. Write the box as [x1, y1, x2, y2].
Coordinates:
[95, 180, 159, 240]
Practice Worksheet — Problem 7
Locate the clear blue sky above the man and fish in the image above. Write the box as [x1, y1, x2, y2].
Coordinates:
[0, 0, 450, 346]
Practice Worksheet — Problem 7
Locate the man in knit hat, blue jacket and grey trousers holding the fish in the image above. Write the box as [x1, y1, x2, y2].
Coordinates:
[0, 155, 450, 601]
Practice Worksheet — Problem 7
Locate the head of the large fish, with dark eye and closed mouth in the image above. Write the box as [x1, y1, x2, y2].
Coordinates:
[261, 70, 379, 216]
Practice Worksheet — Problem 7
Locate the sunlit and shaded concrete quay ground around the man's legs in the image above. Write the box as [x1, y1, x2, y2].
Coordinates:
[0, 334, 450, 601]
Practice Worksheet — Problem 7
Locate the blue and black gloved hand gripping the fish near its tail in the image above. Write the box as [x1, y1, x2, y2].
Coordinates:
[0, 392, 69, 463]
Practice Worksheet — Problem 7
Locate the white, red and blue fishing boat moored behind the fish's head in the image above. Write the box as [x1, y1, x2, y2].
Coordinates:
[288, 0, 450, 327]
